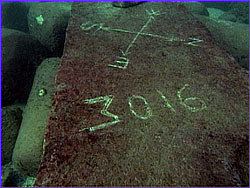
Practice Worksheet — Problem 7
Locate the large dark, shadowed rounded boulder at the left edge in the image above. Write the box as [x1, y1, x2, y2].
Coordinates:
[1, 28, 48, 106]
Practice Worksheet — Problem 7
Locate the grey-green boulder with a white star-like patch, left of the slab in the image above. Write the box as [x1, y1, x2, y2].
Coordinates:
[28, 2, 71, 57]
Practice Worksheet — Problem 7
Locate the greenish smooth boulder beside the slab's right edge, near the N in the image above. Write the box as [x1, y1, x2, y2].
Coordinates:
[197, 16, 249, 70]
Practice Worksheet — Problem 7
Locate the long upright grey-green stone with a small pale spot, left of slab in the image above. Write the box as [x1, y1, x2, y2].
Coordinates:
[12, 58, 60, 176]
